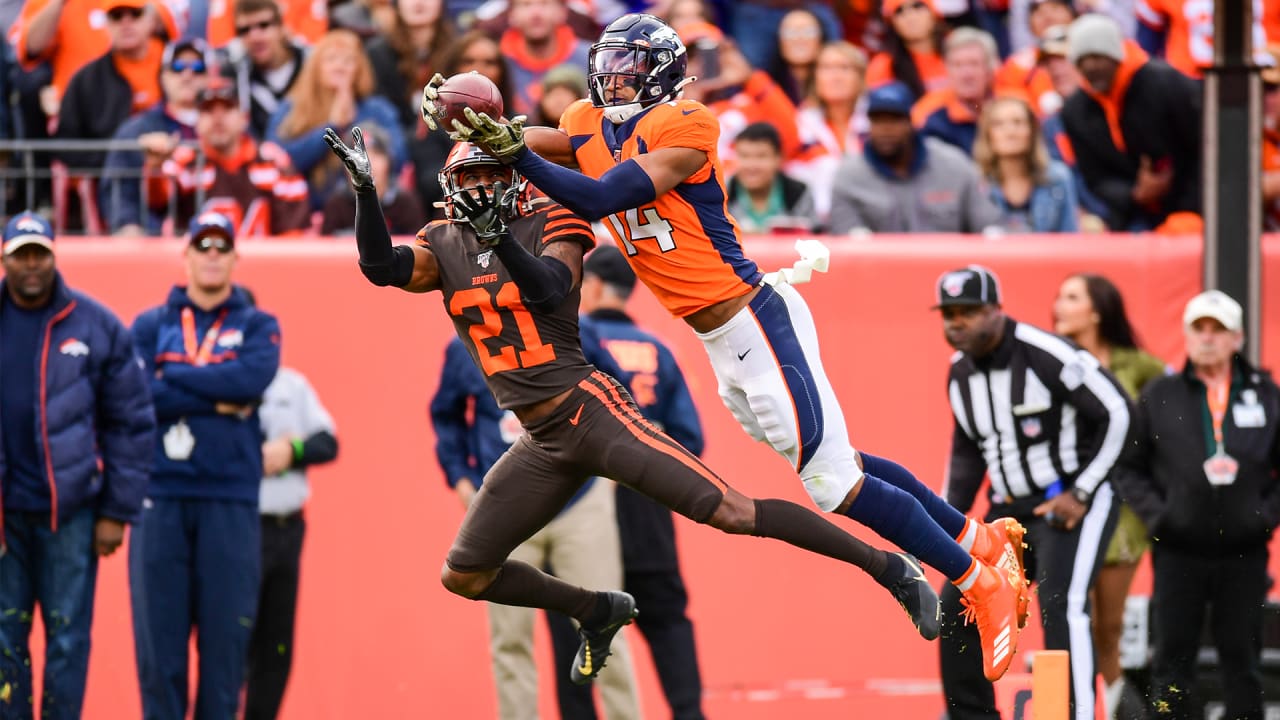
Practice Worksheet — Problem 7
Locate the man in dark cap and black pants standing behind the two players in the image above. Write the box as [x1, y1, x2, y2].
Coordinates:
[581, 245, 704, 720]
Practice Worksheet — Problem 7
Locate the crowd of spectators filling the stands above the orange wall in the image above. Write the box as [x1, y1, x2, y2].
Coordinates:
[0, 0, 1280, 237]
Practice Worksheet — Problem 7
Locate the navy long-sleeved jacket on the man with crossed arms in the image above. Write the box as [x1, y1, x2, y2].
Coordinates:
[133, 287, 280, 505]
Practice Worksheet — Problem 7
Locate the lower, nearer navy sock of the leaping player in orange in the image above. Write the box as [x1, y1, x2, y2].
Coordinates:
[846, 473, 973, 582]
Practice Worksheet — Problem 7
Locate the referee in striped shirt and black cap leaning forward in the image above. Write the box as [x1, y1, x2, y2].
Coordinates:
[936, 265, 1129, 720]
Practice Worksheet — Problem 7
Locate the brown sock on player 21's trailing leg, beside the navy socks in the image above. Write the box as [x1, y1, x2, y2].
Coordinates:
[753, 498, 888, 580]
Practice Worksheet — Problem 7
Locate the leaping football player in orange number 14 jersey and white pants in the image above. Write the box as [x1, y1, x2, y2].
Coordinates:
[422, 14, 1029, 679]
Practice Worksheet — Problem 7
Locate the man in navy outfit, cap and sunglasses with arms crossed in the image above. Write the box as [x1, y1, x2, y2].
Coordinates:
[129, 213, 280, 720]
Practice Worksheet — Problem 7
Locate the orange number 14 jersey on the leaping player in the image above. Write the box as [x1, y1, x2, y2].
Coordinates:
[561, 100, 763, 318]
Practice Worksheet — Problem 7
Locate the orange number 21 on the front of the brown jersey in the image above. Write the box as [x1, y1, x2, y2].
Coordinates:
[449, 282, 556, 375]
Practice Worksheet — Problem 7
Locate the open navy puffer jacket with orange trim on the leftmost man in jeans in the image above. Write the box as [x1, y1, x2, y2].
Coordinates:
[0, 274, 155, 530]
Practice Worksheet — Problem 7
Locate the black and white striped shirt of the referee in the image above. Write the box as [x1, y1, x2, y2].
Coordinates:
[946, 319, 1129, 512]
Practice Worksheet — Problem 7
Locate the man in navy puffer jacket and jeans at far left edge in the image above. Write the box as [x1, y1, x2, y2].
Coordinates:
[0, 213, 155, 719]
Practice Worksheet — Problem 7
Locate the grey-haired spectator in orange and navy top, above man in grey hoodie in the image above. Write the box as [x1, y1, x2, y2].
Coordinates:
[911, 27, 1000, 154]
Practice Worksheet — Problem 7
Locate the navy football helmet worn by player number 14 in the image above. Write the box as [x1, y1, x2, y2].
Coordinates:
[588, 13, 689, 123]
